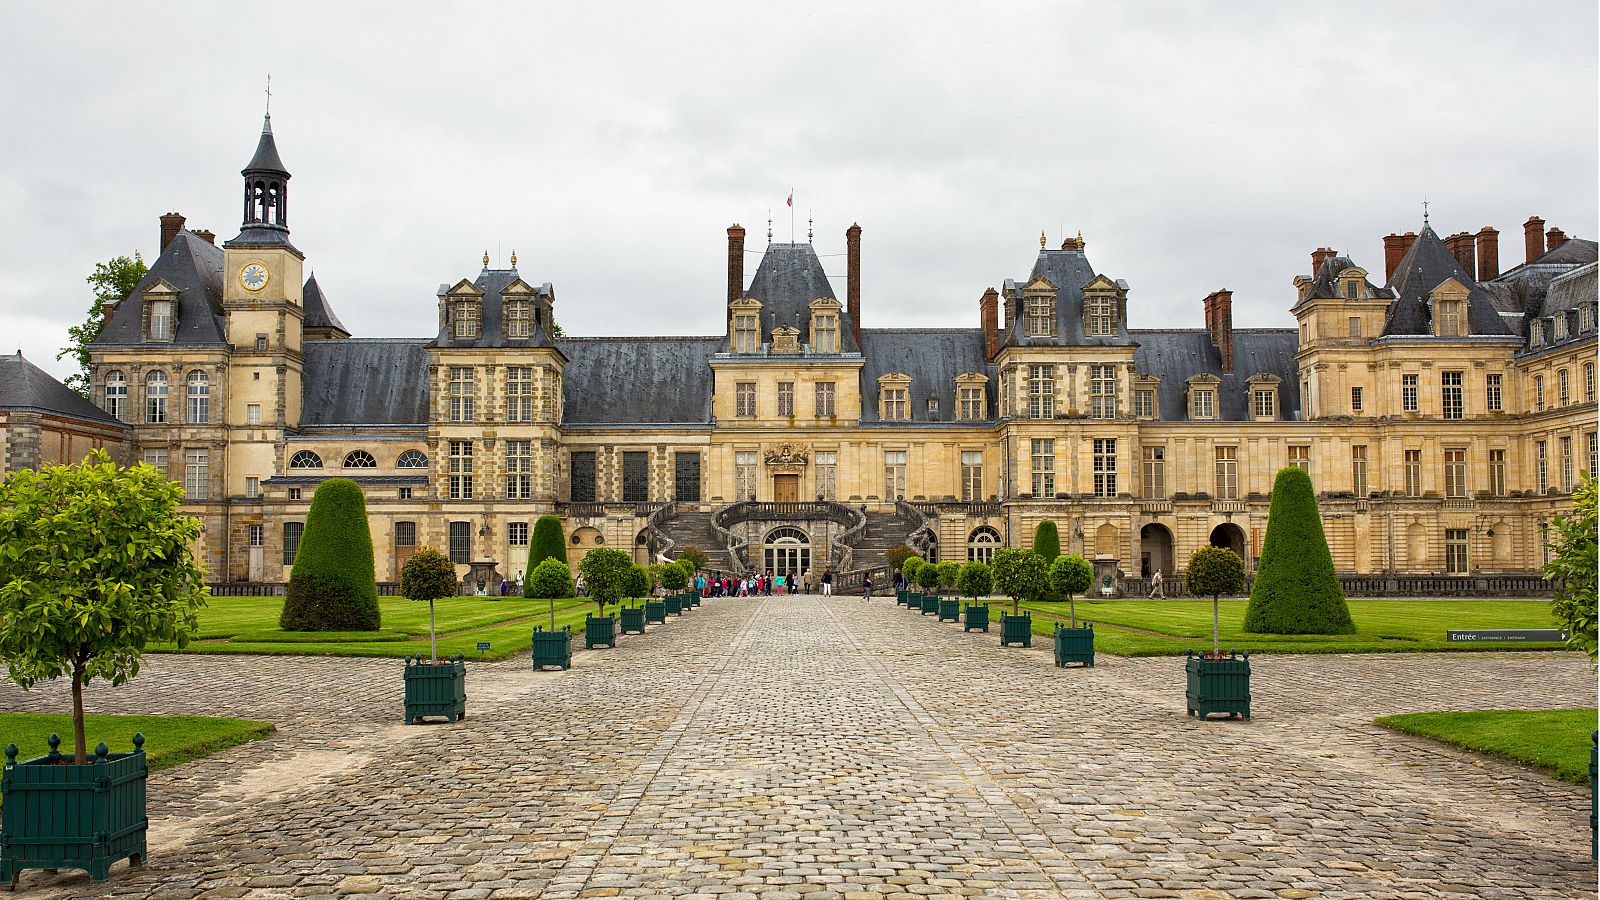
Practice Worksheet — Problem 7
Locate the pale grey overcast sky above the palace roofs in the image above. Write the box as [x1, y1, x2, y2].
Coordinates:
[0, 0, 1600, 375]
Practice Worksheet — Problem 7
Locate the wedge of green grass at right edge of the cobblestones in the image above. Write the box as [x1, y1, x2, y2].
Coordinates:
[1378, 708, 1597, 785]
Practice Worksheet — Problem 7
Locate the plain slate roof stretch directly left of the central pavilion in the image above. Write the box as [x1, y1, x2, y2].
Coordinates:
[555, 335, 726, 424]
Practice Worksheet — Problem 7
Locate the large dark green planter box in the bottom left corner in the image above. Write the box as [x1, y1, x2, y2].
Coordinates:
[0, 733, 150, 887]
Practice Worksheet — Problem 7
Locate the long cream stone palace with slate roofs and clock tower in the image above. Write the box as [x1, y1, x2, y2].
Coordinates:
[77, 112, 1597, 589]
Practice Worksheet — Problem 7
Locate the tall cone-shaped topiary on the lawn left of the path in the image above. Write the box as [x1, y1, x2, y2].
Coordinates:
[278, 479, 382, 631]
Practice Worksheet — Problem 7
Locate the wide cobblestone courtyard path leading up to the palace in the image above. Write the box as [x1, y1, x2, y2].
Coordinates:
[0, 597, 1595, 900]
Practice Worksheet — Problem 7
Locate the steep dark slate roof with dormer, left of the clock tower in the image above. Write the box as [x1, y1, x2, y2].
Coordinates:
[94, 229, 227, 346]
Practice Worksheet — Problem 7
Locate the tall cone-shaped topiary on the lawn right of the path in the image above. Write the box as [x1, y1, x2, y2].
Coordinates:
[1245, 466, 1355, 634]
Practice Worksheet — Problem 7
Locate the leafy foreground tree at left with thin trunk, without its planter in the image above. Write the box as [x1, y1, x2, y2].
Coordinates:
[0, 450, 206, 764]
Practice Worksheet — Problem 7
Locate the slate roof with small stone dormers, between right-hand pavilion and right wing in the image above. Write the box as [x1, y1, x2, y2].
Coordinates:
[1133, 328, 1301, 421]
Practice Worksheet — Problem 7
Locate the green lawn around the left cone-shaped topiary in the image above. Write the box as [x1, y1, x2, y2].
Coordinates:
[155, 597, 616, 660]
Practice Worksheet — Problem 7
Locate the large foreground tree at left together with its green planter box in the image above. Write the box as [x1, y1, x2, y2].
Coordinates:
[0, 450, 206, 886]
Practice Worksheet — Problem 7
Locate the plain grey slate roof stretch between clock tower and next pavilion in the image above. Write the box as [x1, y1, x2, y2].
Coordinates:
[301, 338, 427, 426]
